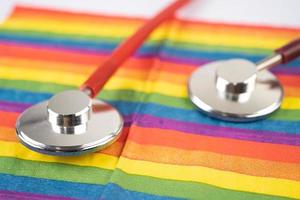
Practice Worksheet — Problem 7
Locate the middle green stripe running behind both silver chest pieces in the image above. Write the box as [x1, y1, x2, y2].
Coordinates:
[0, 79, 300, 121]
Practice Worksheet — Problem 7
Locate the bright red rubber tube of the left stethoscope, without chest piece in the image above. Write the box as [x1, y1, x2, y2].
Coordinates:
[80, 0, 190, 98]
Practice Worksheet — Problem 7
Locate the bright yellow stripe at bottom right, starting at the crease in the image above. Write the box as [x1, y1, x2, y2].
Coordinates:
[117, 157, 300, 198]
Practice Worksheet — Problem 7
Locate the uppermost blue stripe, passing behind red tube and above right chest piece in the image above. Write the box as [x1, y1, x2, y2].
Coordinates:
[0, 33, 300, 67]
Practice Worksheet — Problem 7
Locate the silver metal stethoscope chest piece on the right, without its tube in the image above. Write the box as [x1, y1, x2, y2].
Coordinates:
[188, 59, 283, 122]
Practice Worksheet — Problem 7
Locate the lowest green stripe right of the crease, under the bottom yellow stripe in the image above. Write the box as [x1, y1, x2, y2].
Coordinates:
[111, 170, 287, 200]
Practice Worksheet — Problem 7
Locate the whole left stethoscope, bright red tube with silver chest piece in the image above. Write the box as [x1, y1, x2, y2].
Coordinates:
[16, 0, 189, 156]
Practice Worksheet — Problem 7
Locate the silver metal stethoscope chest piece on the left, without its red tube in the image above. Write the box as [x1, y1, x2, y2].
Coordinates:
[16, 90, 123, 155]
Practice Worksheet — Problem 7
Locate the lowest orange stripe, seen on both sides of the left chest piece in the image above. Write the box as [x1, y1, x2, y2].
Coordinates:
[0, 127, 300, 180]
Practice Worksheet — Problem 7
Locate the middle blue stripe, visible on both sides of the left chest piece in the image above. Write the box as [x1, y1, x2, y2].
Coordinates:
[0, 89, 300, 134]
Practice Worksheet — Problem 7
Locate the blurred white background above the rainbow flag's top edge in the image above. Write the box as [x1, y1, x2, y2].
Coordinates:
[0, 0, 300, 27]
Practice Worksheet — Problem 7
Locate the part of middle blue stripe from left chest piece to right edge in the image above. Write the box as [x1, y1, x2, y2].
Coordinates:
[109, 101, 300, 134]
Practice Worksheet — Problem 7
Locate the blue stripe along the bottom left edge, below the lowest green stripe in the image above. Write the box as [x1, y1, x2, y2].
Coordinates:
[0, 173, 176, 200]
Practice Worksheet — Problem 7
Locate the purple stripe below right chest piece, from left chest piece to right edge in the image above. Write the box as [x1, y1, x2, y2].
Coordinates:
[125, 115, 300, 146]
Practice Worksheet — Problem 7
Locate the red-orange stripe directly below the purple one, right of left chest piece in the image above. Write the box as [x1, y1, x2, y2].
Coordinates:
[128, 126, 300, 163]
